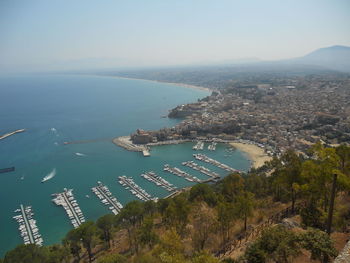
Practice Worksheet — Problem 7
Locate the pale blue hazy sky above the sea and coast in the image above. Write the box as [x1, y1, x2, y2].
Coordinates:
[0, 0, 350, 72]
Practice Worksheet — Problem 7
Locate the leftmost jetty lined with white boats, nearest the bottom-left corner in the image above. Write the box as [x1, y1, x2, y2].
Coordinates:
[13, 204, 44, 246]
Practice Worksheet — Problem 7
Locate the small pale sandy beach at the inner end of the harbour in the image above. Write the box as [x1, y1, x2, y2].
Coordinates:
[230, 142, 272, 168]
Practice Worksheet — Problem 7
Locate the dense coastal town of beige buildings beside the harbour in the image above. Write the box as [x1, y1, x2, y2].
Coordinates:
[131, 74, 350, 155]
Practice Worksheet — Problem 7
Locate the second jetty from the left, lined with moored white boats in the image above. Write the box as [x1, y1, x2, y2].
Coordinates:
[52, 188, 85, 228]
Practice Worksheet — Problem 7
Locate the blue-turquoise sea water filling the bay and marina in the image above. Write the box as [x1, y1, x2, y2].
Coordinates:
[0, 75, 250, 257]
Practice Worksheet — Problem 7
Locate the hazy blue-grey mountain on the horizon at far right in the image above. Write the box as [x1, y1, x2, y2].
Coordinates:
[289, 46, 350, 72]
